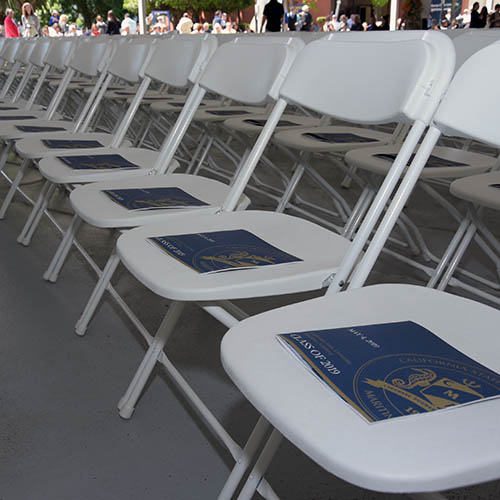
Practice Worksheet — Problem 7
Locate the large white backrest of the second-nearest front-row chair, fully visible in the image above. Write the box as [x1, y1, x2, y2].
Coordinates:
[281, 31, 455, 124]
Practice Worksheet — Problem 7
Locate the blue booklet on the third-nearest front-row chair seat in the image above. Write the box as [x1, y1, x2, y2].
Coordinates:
[103, 187, 208, 210]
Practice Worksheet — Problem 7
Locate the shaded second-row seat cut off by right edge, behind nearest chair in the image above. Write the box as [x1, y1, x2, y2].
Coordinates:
[450, 172, 500, 210]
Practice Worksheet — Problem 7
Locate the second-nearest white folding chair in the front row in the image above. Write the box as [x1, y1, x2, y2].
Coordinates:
[46, 33, 454, 500]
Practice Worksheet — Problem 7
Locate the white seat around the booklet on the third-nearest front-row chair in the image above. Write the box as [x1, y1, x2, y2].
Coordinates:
[70, 174, 250, 228]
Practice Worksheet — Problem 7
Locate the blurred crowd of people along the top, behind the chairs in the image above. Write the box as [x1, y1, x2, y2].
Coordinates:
[2, 0, 500, 37]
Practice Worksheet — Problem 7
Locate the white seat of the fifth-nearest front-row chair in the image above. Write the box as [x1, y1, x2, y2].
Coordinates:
[15, 132, 130, 159]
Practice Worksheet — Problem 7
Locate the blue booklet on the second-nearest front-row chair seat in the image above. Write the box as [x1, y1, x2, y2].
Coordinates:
[149, 229, 302, 274]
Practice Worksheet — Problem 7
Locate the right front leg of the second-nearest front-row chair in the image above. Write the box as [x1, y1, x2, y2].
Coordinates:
[118, 301, 185, 419]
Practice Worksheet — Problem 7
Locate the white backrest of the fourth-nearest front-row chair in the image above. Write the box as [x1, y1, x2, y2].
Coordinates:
[144, 34, 217, 88]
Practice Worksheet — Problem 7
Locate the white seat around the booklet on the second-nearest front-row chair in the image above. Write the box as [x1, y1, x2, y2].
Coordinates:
[117, 210, 350, 301]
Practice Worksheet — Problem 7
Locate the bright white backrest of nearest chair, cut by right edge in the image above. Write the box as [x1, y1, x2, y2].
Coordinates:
[434, 42, 500, 147]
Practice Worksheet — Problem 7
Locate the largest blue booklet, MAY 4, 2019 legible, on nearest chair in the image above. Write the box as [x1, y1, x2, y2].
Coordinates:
[277, 321, 500, 422]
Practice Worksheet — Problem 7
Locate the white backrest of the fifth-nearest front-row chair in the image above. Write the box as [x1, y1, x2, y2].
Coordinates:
[108, 37, 155, 82]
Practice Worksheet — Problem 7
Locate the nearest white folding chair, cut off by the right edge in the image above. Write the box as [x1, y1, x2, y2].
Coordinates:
[220, 38, 500, 500]
